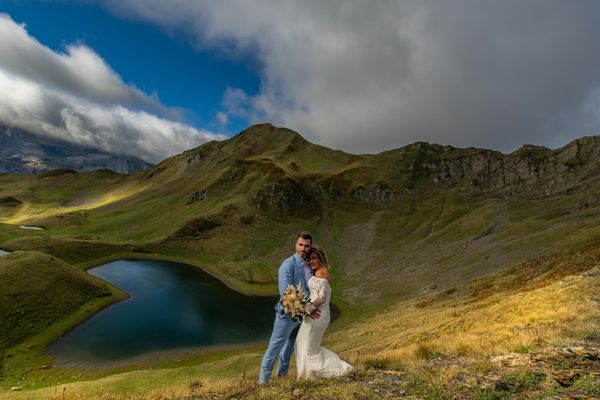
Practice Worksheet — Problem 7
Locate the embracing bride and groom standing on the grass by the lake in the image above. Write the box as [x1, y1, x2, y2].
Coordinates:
[258, 232, 352, 384]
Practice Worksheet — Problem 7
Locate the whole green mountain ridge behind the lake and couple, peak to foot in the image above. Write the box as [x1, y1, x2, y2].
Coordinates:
[0, 124, 600, 306]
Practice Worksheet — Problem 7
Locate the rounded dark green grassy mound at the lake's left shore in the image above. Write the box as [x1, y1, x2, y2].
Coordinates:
[0, 251, 124, 390]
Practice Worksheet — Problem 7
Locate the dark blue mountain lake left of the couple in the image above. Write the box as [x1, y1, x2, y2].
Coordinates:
[48, 260, 277, 364]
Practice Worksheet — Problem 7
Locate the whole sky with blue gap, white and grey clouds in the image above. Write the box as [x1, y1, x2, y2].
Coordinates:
[0, 0, 600, 162]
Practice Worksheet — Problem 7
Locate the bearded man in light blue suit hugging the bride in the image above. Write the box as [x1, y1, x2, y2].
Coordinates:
[258, 232, 321, 384]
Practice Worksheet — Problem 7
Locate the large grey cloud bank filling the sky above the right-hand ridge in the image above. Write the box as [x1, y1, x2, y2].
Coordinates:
[104, 0, 600, 152]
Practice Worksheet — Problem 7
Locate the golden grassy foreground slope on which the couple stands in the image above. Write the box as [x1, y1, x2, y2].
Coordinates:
[0, 239, 600, 400]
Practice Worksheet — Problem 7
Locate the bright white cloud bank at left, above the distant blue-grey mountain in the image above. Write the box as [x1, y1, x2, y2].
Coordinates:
[0, 14, 224, 162]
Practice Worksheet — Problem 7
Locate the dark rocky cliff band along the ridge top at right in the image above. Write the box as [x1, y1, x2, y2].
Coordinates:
[292, 136, 600, 207]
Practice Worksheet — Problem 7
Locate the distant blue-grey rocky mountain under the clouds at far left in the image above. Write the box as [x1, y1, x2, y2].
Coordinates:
[0, 126, 152, 173]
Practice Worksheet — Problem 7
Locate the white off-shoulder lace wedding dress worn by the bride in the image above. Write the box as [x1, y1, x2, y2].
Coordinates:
[295, 276, 352, 379]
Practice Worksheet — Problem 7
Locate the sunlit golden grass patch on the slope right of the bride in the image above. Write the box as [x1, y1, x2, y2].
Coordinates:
[327, 242, 600, 364]
